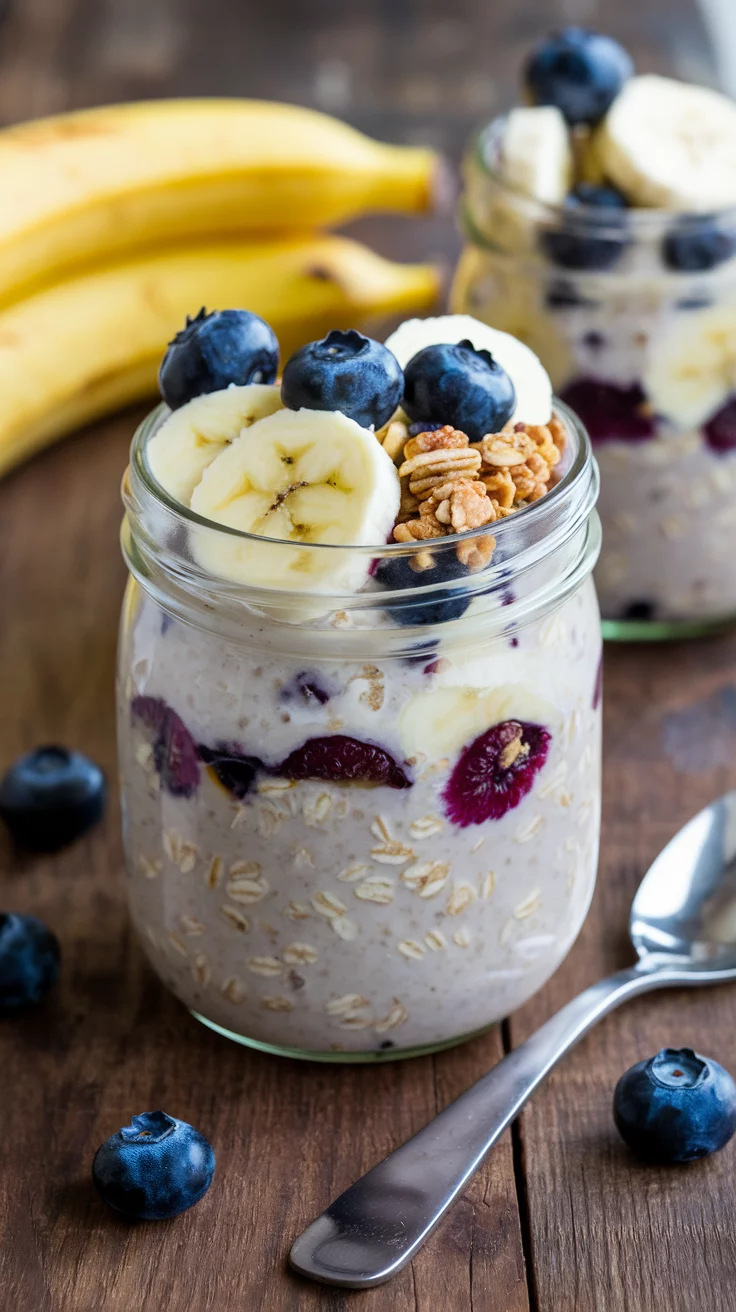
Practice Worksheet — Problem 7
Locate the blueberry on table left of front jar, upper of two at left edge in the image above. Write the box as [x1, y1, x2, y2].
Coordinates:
[0, 747, 108, 851]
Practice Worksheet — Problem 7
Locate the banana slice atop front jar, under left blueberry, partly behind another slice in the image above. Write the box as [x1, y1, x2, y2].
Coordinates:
[146, 383, 282, 505]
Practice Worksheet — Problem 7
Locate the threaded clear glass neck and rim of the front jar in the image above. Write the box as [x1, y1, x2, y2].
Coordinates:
[122, 400, 600, 652]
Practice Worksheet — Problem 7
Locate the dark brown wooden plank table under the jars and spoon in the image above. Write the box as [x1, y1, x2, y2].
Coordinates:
[0, 0, 736, 1312]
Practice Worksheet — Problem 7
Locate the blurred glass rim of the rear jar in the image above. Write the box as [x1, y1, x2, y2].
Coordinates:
[466, 114, 736, 241]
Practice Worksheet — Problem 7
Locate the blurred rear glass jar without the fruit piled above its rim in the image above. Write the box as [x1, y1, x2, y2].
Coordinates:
[453, 119, 736, 638]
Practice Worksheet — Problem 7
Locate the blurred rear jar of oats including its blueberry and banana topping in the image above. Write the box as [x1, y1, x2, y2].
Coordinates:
[453, 29, 736, 636]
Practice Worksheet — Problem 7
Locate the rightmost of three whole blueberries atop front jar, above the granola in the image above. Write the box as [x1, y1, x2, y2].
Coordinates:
[404, 341, 516, 442]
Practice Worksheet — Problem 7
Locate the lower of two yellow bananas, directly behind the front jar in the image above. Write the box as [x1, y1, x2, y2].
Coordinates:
[0, 236, 440, 474]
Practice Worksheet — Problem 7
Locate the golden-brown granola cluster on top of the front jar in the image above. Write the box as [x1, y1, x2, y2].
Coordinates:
[378, 417, 564, 569]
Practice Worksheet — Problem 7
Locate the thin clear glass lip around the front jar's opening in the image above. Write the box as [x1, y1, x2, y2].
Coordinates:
[130, 398, 596, 566]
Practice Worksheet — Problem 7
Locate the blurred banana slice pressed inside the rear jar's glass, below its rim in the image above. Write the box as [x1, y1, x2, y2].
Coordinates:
[643, 306, 736, 429]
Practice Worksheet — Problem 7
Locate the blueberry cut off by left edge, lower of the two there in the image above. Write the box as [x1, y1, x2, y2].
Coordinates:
[0, 912, 62, 1015]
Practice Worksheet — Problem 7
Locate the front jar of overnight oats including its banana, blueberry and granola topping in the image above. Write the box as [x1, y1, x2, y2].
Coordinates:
[118, 311, 601, 1060]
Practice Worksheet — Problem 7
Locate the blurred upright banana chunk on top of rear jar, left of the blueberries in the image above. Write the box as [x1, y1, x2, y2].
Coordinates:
[501, 105, 573, 205]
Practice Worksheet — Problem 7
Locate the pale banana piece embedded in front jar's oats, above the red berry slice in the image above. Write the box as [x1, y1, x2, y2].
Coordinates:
[399, 684, 560, 760]
